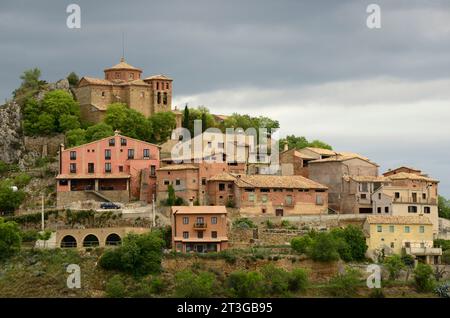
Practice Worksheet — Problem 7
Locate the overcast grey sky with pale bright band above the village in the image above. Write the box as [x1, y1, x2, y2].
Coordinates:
[0, 0, 450, 197]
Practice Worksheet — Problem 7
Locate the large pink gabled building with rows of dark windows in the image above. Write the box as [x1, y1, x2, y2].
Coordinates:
[56, 132, 159, 207]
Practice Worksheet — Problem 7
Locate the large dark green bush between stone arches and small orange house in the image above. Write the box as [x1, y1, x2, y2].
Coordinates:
[99, 232, 164, 275]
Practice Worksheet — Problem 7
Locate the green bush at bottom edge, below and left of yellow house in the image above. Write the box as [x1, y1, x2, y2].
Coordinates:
[327, 268, 362, 297]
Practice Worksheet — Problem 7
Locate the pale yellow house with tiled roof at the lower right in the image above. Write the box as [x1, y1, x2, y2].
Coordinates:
[364, 215, 442, 264]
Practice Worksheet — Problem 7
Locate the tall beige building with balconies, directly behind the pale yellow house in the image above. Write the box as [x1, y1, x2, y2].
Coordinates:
[372, 172, 439, 238]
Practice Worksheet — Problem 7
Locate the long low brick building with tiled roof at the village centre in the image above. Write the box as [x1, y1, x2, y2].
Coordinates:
[207, 173, 328, 216]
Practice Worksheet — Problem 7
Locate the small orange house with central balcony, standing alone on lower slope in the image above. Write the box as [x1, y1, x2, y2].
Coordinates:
[172, 206, 228, 253]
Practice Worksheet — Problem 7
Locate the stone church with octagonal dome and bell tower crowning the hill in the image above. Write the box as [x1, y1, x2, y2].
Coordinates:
[74, 57, 181, 126]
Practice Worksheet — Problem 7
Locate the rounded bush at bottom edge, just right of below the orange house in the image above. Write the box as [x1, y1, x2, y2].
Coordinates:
[225, 271, 264, 298]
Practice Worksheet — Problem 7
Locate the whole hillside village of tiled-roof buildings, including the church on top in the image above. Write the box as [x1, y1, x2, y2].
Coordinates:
[0, 58, 450, 298]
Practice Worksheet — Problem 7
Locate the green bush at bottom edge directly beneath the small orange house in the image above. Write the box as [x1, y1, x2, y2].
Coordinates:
[175, 270, 217, 298]
